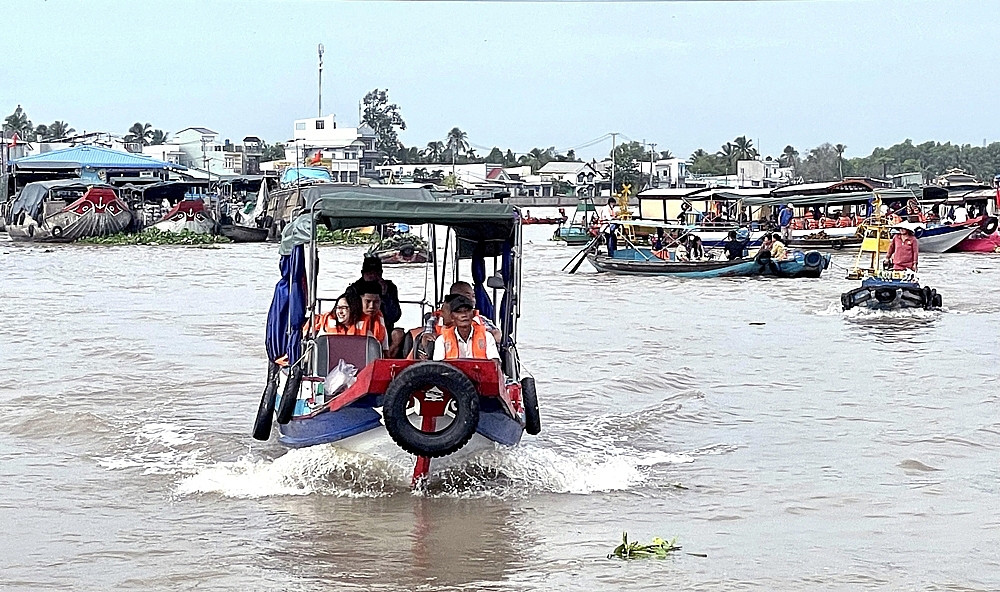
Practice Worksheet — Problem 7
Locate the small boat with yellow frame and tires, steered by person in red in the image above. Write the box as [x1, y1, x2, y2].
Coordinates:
[840, 199, 942, 310]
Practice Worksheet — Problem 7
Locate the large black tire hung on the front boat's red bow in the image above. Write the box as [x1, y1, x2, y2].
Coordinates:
[382, 362, 479, 458]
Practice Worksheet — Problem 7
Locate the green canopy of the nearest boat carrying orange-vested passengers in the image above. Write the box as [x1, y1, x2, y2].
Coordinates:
[280, 185, 518, 255]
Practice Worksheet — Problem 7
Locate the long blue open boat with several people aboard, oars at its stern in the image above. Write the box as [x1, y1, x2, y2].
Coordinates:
[585, 220, 831, 278]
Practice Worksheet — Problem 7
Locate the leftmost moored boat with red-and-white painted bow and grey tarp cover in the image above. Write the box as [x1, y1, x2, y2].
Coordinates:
[6, 179, 132, 242]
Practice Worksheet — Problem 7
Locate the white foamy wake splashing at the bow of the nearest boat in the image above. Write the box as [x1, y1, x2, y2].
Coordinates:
[176, 445, 694, 498]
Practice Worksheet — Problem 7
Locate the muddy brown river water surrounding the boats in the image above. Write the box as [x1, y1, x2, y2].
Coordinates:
[0, 227, 1000, 591]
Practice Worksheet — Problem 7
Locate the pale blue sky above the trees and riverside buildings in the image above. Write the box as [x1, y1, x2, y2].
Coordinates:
[0, 0, 1000, 158]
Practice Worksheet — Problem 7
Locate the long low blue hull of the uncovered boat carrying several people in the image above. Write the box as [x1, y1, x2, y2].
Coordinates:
[587, 251, 830, 279]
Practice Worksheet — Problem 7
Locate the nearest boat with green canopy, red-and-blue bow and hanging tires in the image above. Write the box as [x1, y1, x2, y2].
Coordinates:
[253, 185, 541, 485]
